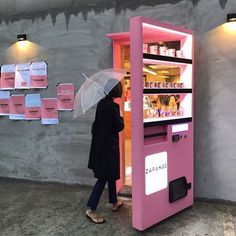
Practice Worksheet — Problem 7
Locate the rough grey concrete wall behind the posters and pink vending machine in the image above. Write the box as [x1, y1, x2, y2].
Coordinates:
[0, 0, 236, 201]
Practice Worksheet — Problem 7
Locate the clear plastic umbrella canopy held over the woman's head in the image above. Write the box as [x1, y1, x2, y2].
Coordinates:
[73, 69, 126, 119]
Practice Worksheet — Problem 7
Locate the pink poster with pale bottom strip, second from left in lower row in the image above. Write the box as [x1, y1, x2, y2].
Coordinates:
[9, 94, 25, 120]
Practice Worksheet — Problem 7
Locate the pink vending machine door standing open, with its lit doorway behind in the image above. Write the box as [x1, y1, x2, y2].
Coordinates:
[107, 16, 193, 230]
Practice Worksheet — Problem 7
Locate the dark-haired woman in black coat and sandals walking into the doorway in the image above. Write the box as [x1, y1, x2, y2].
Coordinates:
[86, 79, 124, 224]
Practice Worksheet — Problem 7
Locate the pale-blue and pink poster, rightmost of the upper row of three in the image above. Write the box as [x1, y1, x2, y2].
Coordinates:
[30, 61, 48, 88]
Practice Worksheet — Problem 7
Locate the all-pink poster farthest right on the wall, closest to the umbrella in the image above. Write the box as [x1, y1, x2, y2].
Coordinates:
[57, 83, 75, 111]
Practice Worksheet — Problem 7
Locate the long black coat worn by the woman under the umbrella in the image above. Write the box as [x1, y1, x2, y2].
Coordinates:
[88, 96, 124, 180]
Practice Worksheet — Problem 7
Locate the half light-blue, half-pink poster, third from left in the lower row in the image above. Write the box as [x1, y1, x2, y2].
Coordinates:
[25, 94, 41, 120]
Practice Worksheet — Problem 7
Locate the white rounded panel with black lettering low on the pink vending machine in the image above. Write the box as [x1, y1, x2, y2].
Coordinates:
[145, 152, 168, 195]
